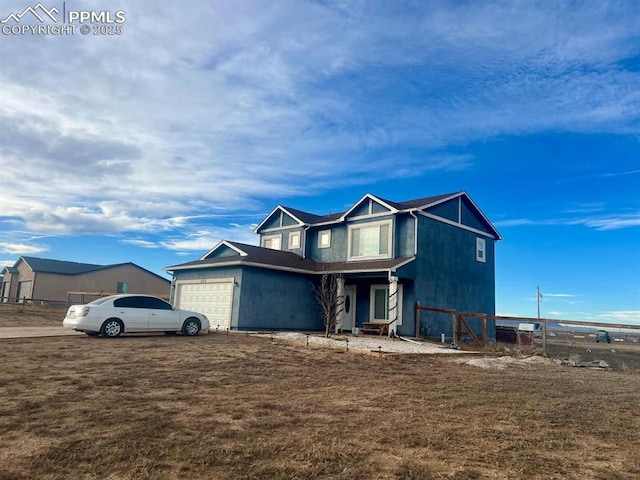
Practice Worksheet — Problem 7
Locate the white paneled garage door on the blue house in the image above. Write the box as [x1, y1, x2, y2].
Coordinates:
[176, 279, 233, 330]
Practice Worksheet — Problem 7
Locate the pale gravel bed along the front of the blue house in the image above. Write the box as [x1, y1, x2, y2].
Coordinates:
[255, 332, 470, 354]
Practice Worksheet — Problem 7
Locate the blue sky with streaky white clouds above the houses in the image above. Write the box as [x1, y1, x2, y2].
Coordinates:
[0, 0, 640, 323]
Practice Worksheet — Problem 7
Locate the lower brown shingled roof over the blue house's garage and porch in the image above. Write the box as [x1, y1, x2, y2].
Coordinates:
[165, 240, 413, 274]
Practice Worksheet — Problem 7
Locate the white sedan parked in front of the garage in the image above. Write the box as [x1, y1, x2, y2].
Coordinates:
[62, 295, 210, 338]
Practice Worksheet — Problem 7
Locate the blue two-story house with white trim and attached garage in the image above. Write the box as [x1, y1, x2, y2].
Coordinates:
[166, 192, 501, 338]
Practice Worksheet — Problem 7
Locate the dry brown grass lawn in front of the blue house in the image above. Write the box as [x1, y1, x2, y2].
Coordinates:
[0, 306, 640, 480]
